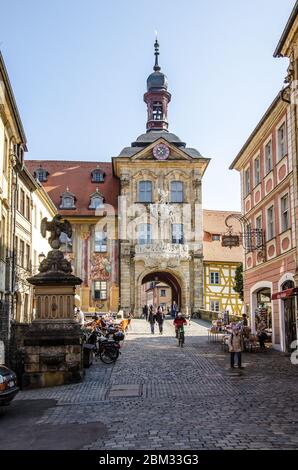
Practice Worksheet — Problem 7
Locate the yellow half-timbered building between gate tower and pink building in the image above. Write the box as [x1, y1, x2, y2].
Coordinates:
[203, 210, 243, 315]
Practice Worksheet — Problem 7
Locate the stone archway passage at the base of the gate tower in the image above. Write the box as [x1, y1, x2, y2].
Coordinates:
[135, 269, 184, 316]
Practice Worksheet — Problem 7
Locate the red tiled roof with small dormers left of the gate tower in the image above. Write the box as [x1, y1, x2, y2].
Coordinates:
[25, 160, 120, 216]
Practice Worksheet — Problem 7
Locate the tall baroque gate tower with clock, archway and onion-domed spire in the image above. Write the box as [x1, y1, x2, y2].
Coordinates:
[113, 39, 209, 316]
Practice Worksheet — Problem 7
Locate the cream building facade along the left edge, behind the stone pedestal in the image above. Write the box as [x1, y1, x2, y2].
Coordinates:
[0, 53, 56, 361]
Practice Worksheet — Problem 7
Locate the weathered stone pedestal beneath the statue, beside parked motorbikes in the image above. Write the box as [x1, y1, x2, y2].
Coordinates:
[22, 250, 84, 389]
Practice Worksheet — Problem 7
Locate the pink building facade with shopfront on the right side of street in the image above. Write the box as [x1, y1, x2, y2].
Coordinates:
[230, 94, 297, 351]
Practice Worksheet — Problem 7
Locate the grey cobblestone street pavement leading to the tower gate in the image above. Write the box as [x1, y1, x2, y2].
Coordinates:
[9, 320, 298, 450]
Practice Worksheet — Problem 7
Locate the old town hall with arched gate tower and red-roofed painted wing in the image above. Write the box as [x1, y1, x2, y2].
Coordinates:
[27, 40, 209, 315]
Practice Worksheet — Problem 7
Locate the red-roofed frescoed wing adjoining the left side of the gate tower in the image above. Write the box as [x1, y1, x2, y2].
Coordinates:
[26, 160, 119, 313]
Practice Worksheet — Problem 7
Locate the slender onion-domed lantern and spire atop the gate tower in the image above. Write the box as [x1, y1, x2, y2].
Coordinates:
[144, 39, 171, 132]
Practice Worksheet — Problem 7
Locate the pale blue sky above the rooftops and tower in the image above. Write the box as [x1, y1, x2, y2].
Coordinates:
[0, 0, 295, 210]
